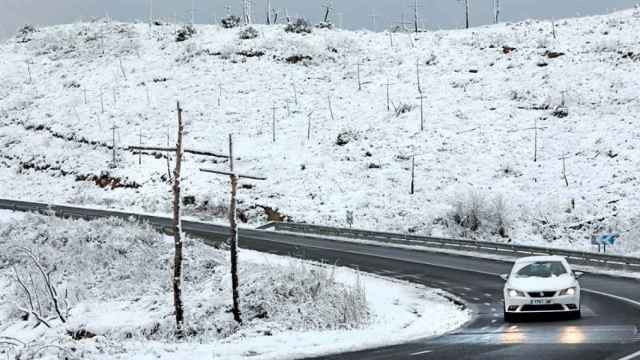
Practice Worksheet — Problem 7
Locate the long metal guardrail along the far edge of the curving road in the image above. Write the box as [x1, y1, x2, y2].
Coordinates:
[265, 223, 640, 271]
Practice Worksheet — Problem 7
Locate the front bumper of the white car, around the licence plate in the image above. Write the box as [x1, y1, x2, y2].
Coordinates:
[504, 294, 580, 313]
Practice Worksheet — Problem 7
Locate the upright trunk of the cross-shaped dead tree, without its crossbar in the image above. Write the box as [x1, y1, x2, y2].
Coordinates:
[229, 134, 242, 323]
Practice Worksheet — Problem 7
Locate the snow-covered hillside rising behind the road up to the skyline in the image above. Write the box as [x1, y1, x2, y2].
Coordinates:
[0, 10, 640, 254]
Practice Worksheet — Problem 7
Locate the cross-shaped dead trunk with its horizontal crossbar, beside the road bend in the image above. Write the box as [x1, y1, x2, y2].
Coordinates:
[200, 134, 267, 324]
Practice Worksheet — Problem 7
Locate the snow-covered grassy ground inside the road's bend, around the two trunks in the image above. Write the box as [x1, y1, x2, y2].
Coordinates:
[0, 210, 470, 359]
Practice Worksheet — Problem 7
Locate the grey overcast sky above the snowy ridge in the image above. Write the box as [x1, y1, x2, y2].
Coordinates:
[0, 0, 638, 37]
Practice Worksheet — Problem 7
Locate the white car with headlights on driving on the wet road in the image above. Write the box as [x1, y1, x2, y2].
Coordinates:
[501, 256, 584, 322]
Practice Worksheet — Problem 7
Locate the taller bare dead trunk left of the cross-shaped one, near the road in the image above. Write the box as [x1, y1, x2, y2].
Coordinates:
[173, 103, 184, 338]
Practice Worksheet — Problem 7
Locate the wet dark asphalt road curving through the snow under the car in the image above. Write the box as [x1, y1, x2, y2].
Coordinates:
[0, 202, 640, 360]
